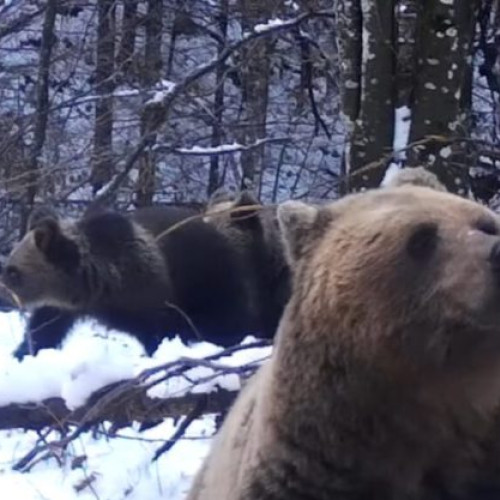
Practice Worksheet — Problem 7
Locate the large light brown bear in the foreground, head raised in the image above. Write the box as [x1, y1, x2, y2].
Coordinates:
[187, 186, 500, 500]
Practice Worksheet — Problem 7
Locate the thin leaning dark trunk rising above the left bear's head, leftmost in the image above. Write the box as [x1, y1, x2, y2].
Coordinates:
[21, 0, 58, 235]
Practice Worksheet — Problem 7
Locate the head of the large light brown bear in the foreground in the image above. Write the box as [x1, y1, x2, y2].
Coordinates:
[278, 186, 500, 369]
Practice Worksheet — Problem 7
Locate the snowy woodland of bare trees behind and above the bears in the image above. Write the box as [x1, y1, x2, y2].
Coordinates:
[0, 0, 500, 254]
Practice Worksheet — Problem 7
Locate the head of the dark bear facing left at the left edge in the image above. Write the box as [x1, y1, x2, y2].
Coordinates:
[2, 216, 81, 309]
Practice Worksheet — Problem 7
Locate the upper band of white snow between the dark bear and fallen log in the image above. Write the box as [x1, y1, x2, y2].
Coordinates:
[0, 313, 271, 409]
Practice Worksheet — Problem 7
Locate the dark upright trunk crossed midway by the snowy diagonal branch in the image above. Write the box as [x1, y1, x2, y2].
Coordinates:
[135, 0, 163, 207]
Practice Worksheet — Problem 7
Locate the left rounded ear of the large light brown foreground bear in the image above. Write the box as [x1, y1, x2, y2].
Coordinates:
[278, 201, 331, 263]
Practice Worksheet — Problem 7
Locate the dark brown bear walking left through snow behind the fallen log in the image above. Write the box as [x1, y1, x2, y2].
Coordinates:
[3, 203, 274, 358]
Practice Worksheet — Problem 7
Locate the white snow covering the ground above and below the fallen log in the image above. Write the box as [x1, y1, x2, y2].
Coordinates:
[0, 313, 270, 500]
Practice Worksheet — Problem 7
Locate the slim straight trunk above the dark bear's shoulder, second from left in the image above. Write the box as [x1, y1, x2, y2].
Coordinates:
[90, 0, 115, 194]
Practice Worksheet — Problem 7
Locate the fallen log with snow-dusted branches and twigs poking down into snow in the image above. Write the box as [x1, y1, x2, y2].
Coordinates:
[0, 340, 270, 472]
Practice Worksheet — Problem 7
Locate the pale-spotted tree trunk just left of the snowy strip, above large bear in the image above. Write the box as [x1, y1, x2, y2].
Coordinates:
[337, 0, 396, 191]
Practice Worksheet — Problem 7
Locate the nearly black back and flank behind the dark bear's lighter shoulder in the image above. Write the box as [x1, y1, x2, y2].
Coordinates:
[130, 207, 259, 345]
